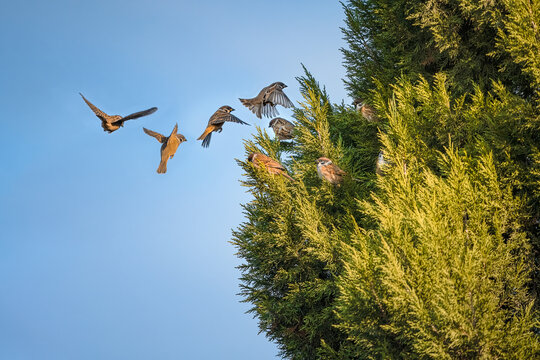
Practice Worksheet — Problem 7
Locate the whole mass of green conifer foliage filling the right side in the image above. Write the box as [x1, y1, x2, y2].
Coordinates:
[233, 0, 540, 359]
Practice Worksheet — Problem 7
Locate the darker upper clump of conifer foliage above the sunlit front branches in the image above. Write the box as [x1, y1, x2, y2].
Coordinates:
[342, 0, 539, 97]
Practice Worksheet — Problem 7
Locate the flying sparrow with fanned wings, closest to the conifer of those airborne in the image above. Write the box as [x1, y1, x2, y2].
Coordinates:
[239, 82, 293, 119]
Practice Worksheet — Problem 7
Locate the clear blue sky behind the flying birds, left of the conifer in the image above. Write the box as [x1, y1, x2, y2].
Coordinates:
[0, 0, 350, 360]
